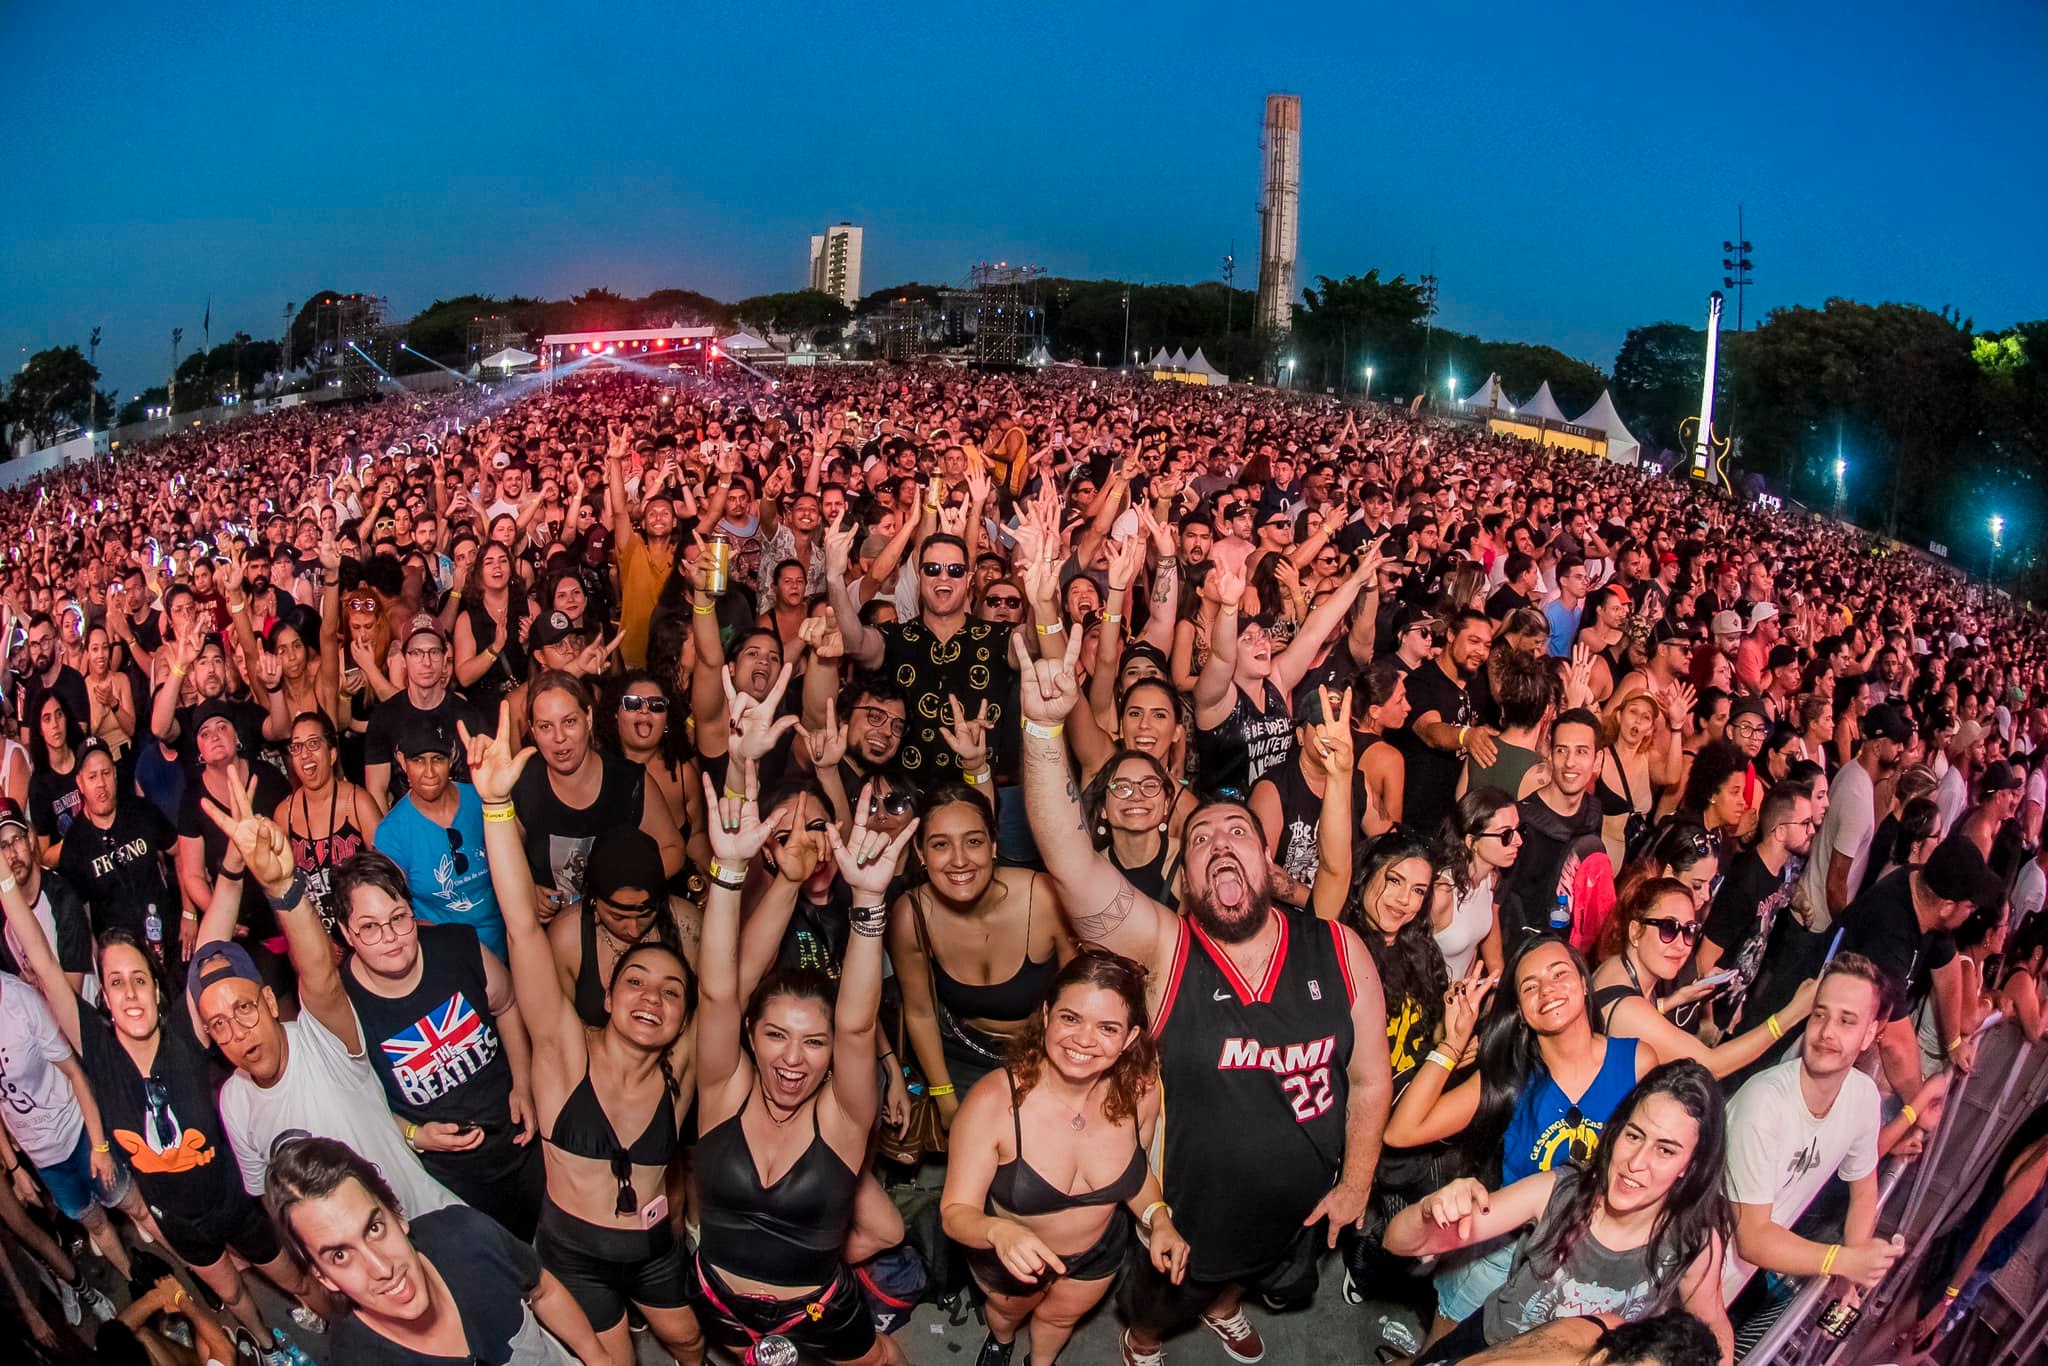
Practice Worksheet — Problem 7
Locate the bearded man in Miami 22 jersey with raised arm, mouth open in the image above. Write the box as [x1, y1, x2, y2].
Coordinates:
[1018, 641, 1393, 1366]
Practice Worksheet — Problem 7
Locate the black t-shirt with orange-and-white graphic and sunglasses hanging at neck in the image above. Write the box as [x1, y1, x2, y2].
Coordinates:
[78, 1015, 250, 1229]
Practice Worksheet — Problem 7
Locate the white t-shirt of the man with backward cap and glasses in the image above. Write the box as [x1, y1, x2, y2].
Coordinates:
[221, 1010, 461, 1216]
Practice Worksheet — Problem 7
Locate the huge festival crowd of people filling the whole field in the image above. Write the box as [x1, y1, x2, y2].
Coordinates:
[0, 367, 2048, 1366]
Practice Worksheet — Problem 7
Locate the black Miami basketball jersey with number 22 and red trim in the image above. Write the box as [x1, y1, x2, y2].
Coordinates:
[1153, 907, 1354, 1280]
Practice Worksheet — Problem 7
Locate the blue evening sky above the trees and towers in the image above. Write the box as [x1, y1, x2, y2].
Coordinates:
[0, 0, 2048, 393]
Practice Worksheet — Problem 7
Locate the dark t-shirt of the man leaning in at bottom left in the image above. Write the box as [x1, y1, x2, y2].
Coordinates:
[328, 1204, 541, 1366]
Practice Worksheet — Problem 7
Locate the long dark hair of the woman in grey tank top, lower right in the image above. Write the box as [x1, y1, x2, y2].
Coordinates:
[1528, 1059, 1735, 1309]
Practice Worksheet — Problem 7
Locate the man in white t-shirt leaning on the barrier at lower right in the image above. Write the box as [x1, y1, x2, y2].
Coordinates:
[1720, 952, 1905, 1303]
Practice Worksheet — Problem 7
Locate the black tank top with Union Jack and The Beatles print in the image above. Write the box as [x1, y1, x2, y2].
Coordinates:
[342, 922, 512, 1147]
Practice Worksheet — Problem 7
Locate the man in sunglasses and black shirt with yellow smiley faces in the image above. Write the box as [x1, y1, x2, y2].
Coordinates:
[825, 520, 1015, 784]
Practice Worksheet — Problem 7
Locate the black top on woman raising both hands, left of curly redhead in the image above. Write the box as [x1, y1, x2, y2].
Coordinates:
[696, 1090, 860, 1286]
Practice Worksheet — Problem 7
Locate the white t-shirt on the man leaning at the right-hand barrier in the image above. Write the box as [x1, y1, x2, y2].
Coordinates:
[1720, 1053, 1882, 1300]
